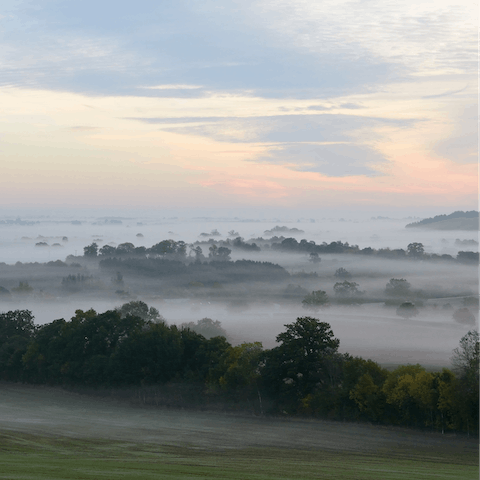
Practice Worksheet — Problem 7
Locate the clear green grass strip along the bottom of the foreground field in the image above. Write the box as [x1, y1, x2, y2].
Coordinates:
[0, 431, 479, 480]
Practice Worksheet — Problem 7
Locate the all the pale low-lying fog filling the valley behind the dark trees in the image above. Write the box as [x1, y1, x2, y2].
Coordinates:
[0, 212, 478, 366]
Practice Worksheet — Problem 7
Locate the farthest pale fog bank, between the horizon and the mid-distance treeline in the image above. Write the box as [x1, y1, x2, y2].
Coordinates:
[0, 211, 478, 263]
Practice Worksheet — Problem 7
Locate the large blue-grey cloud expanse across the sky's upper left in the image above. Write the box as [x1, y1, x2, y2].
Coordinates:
[0, 0, 389, 98]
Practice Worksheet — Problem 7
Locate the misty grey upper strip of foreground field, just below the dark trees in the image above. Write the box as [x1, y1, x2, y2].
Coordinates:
[0, 384, 475, 459]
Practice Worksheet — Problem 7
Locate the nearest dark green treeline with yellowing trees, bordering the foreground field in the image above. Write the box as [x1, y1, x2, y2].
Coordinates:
[0, 308, 480, 433]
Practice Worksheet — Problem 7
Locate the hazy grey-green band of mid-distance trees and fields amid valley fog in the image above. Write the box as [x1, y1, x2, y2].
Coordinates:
[0, 237, 478, 316]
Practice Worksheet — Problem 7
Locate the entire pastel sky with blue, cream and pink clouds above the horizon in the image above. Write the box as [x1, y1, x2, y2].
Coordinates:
[0, 0, 478, 214]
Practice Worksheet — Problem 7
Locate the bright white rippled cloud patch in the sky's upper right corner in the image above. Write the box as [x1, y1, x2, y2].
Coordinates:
[253, 0, 478, 75]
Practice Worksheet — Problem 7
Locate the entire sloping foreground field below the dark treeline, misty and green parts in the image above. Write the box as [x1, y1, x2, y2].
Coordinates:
[0, 383, 478, 480]
